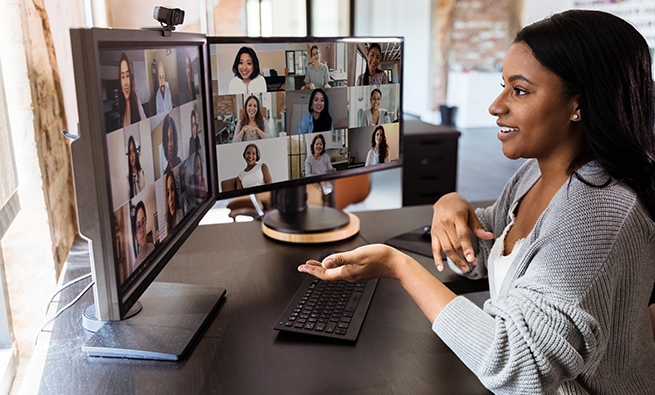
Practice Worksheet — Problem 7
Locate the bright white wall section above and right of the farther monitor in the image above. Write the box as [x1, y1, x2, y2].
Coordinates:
[355, 0, 432, 114]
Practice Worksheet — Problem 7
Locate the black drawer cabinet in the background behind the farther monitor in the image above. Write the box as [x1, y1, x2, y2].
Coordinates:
[403, 120, 461, 206]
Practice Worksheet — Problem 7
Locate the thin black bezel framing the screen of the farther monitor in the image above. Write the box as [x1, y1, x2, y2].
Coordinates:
[207, 36, 405, 200]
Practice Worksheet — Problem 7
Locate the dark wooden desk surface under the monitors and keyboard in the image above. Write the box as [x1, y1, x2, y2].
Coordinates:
[22, 206, 489, 395]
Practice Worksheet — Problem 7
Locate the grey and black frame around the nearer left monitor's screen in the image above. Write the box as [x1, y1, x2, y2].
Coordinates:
[71, 28, 217, 321]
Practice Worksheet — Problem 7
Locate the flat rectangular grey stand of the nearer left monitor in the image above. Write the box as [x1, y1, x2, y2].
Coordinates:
[82, 282, 225, 361]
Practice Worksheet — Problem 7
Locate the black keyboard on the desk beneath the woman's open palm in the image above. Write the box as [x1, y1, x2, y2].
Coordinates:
[273, 275, 378, 341]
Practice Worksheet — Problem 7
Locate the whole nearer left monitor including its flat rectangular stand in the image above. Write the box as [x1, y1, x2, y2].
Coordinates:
[71, 29, 225, 359]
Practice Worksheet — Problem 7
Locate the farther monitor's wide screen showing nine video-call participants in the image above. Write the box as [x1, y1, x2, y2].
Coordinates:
[208, 37, 403, 198]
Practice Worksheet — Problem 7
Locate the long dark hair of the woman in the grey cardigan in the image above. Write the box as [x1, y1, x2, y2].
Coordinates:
[514, 10, 655, 217]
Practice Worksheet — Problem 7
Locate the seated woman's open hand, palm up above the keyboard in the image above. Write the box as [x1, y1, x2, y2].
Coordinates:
[298, 244, 406, 282]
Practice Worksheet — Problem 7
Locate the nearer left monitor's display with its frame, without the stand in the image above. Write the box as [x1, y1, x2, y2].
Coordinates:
[71, 29, 213, 320]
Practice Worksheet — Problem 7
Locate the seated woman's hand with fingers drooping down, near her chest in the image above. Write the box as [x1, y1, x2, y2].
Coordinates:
[431, 192, 495, 272]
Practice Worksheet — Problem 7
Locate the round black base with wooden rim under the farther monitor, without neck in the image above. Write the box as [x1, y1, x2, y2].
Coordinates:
[262, 206, 359, 244]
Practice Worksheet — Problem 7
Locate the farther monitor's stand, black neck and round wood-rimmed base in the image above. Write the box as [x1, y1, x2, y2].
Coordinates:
[262, 185, 359, 243]
